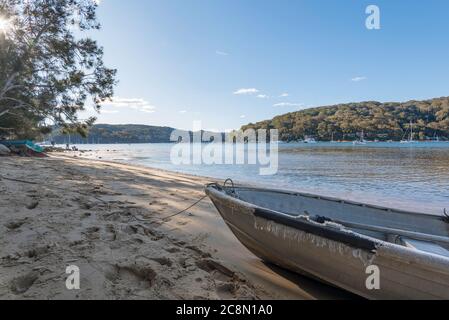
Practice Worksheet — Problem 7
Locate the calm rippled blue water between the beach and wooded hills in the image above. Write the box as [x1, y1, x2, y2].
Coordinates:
[71, 142, 449, 214]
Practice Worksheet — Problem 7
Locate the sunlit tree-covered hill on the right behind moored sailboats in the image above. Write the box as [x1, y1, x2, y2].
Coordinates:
[242, 97, 449, 141]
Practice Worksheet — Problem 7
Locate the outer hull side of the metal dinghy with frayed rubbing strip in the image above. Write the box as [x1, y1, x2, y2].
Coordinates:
[206, 187, 449, 299]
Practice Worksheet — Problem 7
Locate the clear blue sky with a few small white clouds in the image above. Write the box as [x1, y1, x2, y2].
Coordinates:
[84, 0, 449, 130]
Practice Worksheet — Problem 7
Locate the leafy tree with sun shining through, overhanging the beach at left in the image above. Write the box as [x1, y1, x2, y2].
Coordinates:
[0, 0, 116, 140]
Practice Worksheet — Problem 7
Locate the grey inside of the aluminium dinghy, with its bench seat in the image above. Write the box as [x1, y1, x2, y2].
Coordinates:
[226, 187, 449, 258]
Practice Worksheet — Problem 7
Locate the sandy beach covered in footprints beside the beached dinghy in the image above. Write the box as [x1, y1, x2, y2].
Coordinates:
[0, 154, 353, 299]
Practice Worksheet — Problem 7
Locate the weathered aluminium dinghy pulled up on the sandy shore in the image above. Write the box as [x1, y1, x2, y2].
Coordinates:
[205, 183, 449, 299]
